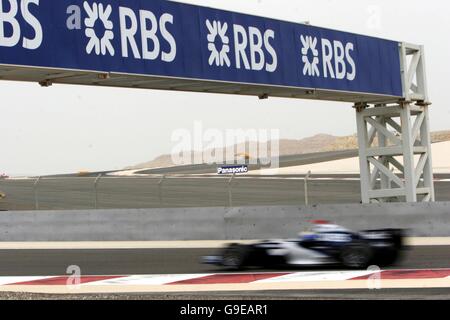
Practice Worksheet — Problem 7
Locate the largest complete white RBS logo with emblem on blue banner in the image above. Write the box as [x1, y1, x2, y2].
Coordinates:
[66, 1, 177, 62]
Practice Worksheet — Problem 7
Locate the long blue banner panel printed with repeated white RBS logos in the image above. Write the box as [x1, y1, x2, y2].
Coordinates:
[0, 0, 403, 97]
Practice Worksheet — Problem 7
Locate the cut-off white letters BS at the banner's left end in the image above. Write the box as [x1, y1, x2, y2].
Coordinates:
[0, 0, 43, 50]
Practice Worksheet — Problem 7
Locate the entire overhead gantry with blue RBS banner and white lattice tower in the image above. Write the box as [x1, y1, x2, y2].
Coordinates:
[0, 0, 434, 202]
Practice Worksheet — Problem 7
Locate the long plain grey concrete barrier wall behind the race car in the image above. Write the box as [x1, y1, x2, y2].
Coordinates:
[0, 202, 450, 241]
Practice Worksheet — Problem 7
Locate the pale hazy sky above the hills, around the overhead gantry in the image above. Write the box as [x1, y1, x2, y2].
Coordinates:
[0, 0, 450, 175]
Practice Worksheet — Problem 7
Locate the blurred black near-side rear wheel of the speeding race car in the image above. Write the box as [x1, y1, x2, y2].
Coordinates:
[339, 242, 372, 269]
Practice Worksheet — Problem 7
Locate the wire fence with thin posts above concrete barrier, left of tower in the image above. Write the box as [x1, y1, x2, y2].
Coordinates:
[0, 176, 360, 210]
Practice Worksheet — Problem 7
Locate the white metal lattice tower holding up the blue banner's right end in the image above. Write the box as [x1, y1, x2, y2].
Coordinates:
[355, 43, 435, 203]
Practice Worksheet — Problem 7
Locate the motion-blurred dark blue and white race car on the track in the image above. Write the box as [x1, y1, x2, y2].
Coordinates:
[202, 220, 405, 270]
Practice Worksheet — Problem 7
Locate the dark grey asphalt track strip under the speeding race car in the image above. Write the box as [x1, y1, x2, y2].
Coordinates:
[0, 246, 450, 276]
